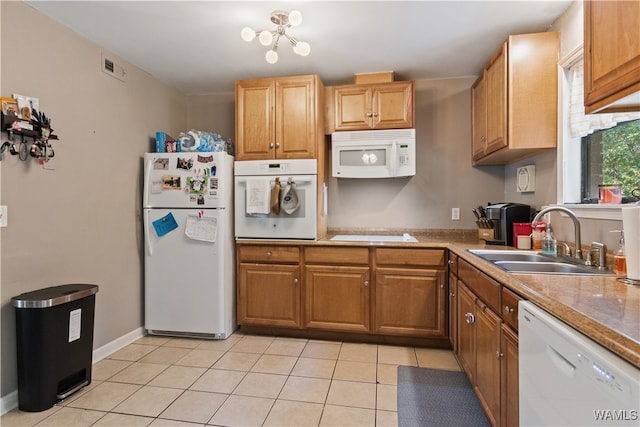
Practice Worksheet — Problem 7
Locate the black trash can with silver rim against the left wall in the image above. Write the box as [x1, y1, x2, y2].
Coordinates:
[11, 284, 98, 412]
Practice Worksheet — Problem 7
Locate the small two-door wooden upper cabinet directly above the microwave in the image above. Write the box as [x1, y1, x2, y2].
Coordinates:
[326, 81, 415, 133]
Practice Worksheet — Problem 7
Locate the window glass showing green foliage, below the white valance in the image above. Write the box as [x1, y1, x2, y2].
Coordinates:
[581, 120, 640, 203]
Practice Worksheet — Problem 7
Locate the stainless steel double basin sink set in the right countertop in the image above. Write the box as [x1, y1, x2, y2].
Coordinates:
[469, 249, 615, 276]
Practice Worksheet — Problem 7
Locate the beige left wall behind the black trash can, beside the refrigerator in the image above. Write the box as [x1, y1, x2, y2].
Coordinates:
[0, 1, 186, 397]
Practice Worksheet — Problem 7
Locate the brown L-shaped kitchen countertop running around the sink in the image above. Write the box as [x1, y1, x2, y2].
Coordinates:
[238, 230, 640, 368]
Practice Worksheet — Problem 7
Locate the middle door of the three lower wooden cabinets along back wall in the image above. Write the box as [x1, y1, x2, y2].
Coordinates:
[305, 265, 371, 332]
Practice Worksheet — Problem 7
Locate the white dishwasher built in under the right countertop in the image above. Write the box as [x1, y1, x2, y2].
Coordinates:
[518, 301, 640, 427]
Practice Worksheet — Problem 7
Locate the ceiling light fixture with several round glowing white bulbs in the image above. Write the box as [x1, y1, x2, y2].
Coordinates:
[240, 10, 311, 64]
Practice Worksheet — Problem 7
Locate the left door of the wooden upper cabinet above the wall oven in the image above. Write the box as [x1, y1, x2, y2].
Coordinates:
[236, 79, 275, 160]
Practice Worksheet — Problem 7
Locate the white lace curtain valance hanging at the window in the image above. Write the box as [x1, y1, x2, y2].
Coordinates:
[569, 59, 640, 138]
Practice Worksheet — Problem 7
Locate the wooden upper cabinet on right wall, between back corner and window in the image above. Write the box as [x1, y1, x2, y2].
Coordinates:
[471, 32, 559, 165]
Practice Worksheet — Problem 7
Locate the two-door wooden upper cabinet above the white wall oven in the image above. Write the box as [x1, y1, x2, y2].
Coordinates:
[236, 75, 324, 160]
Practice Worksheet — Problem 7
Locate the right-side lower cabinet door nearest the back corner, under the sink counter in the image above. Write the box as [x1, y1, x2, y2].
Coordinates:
[457, 280, 476, 384]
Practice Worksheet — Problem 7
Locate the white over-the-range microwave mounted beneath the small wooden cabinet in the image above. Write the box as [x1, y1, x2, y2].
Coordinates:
[331, 129, 416, 178]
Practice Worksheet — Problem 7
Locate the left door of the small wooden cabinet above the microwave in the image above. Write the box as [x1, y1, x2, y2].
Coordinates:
[333, 85, 372, 130]
